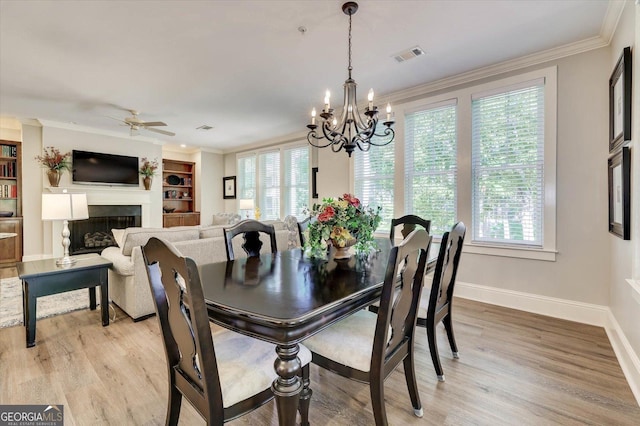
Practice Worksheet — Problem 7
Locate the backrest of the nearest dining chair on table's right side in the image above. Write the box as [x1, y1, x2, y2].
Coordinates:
[372, 229, 431, 369]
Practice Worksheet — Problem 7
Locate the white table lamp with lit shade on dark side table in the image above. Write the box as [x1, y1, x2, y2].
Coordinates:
[42, 189, 89, 266]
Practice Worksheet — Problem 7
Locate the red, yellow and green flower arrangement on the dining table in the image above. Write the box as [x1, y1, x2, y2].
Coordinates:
[305, 194, 382, 257]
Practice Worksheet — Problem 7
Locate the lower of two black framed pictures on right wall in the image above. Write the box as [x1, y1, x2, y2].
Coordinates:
[609, 146, 631, 240]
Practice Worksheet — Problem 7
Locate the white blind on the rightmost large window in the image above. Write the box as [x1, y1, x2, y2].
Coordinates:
[471, 80, 544, 247]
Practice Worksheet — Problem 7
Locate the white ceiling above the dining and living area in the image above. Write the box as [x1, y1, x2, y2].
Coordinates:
[0, 0, 620, 152]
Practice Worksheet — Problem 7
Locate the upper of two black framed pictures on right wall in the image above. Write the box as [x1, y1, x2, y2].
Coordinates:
[609, 47, 631, 152]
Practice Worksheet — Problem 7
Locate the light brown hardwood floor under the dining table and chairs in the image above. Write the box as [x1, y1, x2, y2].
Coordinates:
[0, 299, 640, 426]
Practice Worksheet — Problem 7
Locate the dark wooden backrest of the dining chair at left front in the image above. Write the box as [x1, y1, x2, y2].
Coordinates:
[142, 237, 223, 419]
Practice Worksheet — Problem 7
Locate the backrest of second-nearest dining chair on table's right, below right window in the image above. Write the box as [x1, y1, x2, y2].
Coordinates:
[429, 222, 466, 312]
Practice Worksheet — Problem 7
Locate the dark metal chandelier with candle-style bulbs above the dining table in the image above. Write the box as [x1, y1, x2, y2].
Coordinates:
[307, 1, 395, 157]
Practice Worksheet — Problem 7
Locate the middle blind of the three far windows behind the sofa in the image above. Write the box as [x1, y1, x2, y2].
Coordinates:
[258, 150, 280, 220]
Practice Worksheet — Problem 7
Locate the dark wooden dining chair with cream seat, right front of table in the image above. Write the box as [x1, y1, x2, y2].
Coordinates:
[305, 229, 431, 425]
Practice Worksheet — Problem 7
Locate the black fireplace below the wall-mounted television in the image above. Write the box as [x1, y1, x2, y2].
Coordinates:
[69, 205, 142, 255]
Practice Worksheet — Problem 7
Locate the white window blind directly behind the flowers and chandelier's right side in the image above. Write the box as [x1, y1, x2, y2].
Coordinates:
[356, 132, 395, 231]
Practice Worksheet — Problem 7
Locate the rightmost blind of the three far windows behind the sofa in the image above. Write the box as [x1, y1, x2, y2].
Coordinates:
[282, 146, 309, 220]
